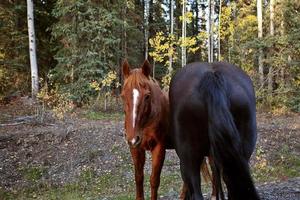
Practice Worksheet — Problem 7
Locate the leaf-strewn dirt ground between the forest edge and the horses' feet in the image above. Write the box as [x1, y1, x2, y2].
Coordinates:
[0, 99, 300, 200]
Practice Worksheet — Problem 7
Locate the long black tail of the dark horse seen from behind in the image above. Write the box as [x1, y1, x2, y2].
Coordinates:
[200, 72, 259, 200]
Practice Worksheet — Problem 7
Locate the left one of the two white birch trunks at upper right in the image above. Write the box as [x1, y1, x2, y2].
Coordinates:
[257, 0, 264, 87]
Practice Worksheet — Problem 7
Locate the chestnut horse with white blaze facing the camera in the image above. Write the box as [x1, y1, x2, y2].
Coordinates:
[121, 60, 169, 200]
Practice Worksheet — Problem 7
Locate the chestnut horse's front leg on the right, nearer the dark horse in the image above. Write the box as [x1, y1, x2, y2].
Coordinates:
[150, 144, 166, 200]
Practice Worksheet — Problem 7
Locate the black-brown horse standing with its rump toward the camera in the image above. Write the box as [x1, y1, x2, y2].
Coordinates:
[169, 63, 259, 200]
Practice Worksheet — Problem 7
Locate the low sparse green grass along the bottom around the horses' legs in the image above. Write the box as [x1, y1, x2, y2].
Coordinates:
[0, 146, 300, 200]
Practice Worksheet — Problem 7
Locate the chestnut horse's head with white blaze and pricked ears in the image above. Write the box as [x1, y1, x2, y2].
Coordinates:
[121, 60, 153, 147]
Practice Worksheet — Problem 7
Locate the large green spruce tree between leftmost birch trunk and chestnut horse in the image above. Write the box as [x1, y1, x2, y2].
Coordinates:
[49, 0, 120, 102]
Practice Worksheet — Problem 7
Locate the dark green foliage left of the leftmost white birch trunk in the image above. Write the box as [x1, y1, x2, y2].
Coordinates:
[0, 1, 29, 96]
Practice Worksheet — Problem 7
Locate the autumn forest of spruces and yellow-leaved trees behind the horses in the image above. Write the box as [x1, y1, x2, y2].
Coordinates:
[0, 0, 300, 111]
